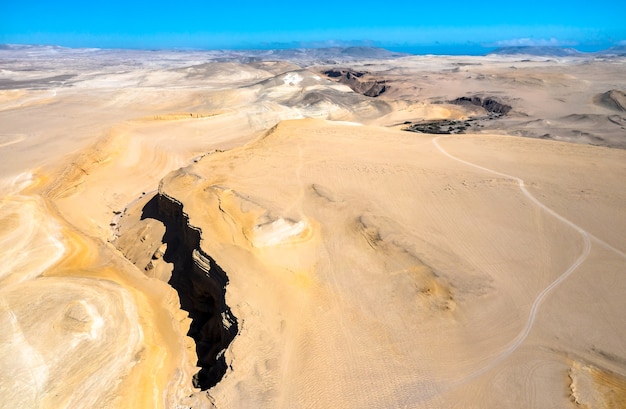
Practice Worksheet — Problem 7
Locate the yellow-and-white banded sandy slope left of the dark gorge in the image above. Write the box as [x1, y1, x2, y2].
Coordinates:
[0, 191, 209, 408]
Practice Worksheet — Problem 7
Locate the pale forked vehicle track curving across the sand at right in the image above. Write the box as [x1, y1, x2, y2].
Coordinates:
[432, 136, 626, 387]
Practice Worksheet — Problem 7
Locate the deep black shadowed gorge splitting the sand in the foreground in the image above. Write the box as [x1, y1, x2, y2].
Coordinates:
[142, 194, 238, 390]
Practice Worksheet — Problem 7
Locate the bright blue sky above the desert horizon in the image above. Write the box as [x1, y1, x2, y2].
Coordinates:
[0, 0, 626, 49]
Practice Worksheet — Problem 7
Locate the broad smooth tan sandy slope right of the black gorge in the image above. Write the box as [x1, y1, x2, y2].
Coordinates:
[149, 121, 626, 407]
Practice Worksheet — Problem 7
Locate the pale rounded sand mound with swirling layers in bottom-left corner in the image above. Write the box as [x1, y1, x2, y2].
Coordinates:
[2, 277, 142, 406]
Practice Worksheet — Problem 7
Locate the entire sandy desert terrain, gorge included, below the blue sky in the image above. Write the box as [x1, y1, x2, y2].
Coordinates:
[0, 47, 626, 409]
